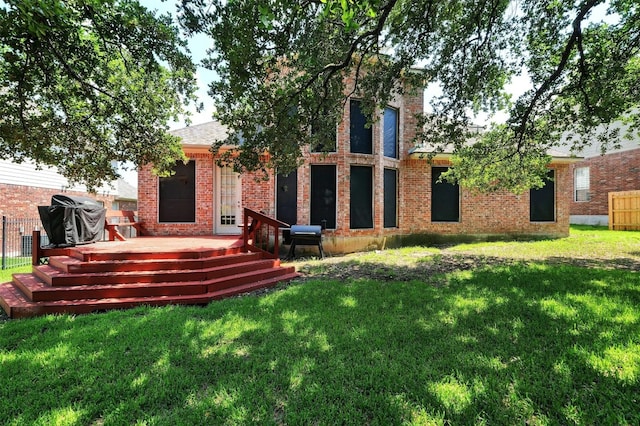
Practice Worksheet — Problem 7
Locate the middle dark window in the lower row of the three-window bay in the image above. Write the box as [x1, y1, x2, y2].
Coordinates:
[349, 166, 373, 229]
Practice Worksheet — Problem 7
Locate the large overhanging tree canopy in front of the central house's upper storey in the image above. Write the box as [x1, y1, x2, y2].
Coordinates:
[180, 0, 640, 191]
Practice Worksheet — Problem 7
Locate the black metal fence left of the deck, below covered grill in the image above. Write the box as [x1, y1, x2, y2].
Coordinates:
[1, 216, 49, 269]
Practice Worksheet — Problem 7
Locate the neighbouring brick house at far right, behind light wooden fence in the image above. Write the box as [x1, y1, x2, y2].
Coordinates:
[570, 135, 640, 226]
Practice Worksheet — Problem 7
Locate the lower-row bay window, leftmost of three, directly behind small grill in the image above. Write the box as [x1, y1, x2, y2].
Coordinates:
[311, 165, 336, 229]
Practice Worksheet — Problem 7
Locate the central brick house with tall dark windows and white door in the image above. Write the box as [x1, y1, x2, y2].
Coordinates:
[138, 78, 574, 252]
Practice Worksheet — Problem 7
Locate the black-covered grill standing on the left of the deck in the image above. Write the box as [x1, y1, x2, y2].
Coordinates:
[38, 194, 107, 247]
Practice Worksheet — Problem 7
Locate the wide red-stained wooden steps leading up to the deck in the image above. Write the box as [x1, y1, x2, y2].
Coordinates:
[0, 247, 298, 318]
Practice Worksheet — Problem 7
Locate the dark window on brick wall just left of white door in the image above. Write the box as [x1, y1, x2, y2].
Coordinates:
[158, 161, 196, 223]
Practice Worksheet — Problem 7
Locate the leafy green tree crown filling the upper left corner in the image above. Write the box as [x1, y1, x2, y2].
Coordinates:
[0, 0, 196, 187]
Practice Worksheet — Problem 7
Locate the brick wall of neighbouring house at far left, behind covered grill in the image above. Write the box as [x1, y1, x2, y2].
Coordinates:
[0, 184, 113, 219]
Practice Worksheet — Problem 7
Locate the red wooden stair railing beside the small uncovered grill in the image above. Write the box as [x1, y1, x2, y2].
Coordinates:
[242, 208, 290, 259]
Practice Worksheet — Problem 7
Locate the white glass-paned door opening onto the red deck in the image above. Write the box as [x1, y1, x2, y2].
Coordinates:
[215, 167, 242, 235]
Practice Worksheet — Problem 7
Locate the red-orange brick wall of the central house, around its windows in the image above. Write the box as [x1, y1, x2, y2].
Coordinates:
[138, 76, 572, 251]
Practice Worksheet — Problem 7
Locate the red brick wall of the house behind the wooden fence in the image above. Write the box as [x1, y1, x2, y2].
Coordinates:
[570, 149, 640, 215]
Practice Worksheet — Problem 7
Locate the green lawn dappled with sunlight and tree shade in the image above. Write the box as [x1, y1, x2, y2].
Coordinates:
[0, 228, 640, 425]
